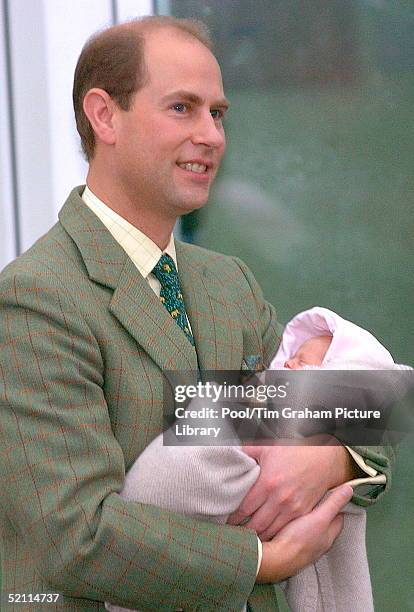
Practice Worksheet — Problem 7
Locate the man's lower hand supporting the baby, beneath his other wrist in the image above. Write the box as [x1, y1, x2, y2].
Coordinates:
[256, 485, 352, 582]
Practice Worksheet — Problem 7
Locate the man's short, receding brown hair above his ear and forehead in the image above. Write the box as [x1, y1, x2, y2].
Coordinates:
[73, 16, 212, 160]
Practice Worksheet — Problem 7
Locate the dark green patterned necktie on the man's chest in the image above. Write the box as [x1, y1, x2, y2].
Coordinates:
[152, 253, 194, 346]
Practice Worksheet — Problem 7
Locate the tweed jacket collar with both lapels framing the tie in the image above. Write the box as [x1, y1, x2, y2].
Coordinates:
[59, 186, 242, 371]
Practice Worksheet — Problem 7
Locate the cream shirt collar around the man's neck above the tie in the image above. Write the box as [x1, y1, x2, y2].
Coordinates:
[82, 186, 178, 278]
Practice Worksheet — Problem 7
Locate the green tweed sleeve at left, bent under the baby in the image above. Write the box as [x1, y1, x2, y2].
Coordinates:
[0, 272, 258, 610]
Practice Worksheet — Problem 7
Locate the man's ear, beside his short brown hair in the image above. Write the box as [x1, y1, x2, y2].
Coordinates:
[83, 87, 116, 145]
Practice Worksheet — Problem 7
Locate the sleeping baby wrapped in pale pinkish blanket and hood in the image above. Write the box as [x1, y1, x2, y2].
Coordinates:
[106, 308, 408, 612]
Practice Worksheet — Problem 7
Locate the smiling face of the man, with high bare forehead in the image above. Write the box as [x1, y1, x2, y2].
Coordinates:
[114, 29, 227, 217]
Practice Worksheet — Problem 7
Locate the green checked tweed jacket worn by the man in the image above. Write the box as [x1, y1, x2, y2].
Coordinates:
[0, 188, 388, 611]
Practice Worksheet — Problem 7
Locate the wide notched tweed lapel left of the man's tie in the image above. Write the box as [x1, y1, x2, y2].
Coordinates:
[59, 187, 197, 371]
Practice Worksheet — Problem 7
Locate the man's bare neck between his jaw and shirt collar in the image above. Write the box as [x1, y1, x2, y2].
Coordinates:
[86, 173, 176, 251]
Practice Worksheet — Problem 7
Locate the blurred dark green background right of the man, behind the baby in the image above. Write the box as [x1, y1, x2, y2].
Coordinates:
[166, 0, 414, 612]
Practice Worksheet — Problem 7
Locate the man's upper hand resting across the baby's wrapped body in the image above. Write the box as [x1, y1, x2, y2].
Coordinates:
[227, 435, 356, 541]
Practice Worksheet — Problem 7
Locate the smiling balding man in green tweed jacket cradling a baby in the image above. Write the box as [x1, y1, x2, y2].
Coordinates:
[0, 18, 388, 610]
